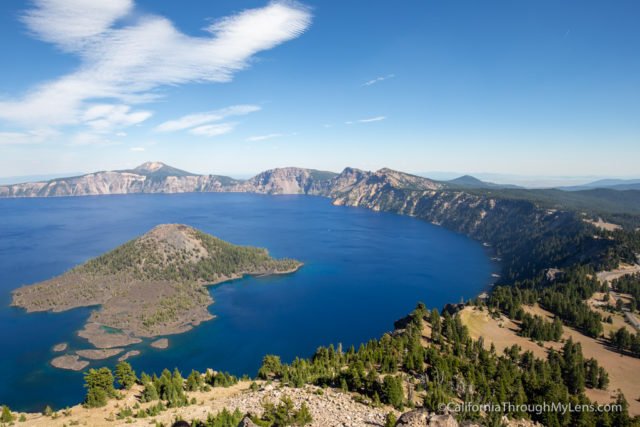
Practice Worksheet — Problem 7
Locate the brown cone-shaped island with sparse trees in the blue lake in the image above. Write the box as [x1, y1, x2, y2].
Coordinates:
[12, 224, 302, 364]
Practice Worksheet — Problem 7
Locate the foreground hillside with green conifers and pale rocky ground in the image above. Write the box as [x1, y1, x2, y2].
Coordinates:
[2, 304, 637, 427]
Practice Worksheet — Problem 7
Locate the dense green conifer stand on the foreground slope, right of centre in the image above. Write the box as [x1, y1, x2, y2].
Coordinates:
[259, 305, 615, 426]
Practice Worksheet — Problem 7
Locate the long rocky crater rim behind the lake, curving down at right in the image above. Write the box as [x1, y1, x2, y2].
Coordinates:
[0, 162, 640, 280]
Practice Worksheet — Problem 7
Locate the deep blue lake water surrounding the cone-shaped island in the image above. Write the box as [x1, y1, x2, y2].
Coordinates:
[0, 193, 498, 410]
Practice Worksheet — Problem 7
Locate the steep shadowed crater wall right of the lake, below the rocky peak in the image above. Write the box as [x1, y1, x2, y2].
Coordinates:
[333, 170, 612, 280]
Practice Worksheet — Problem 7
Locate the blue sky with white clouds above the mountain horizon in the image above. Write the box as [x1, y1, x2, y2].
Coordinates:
[0, 0, 640, 181]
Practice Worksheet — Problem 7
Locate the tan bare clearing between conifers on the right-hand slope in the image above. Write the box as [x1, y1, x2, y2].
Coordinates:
[460, 305, 640, 415]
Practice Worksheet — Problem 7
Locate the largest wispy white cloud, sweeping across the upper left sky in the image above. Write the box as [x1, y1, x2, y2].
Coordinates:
[0, 0, 311, 129]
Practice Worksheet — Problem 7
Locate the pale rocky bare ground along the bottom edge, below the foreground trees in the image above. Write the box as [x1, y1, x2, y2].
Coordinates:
[15, 381, 392, 427]
